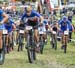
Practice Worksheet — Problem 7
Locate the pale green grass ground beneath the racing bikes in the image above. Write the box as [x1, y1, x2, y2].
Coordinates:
[0, 37, 75, 68]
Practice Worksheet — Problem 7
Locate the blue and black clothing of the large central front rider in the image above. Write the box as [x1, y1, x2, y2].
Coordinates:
[21, 10, 41, 29]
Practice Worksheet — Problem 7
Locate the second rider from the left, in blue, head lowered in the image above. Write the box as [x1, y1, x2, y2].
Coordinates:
[5, 18, 16, 53]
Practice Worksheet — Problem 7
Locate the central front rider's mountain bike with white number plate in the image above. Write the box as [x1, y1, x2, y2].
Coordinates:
[26, 26, 36, 63]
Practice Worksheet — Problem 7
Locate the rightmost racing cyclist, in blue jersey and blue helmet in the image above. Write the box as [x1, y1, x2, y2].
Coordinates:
[59, 16, 72, 49]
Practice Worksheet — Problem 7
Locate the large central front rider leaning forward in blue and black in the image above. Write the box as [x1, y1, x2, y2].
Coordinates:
[21, 6, 43, 51]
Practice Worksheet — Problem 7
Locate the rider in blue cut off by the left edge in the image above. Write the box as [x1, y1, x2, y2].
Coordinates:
[0, 8, 8, 53]
